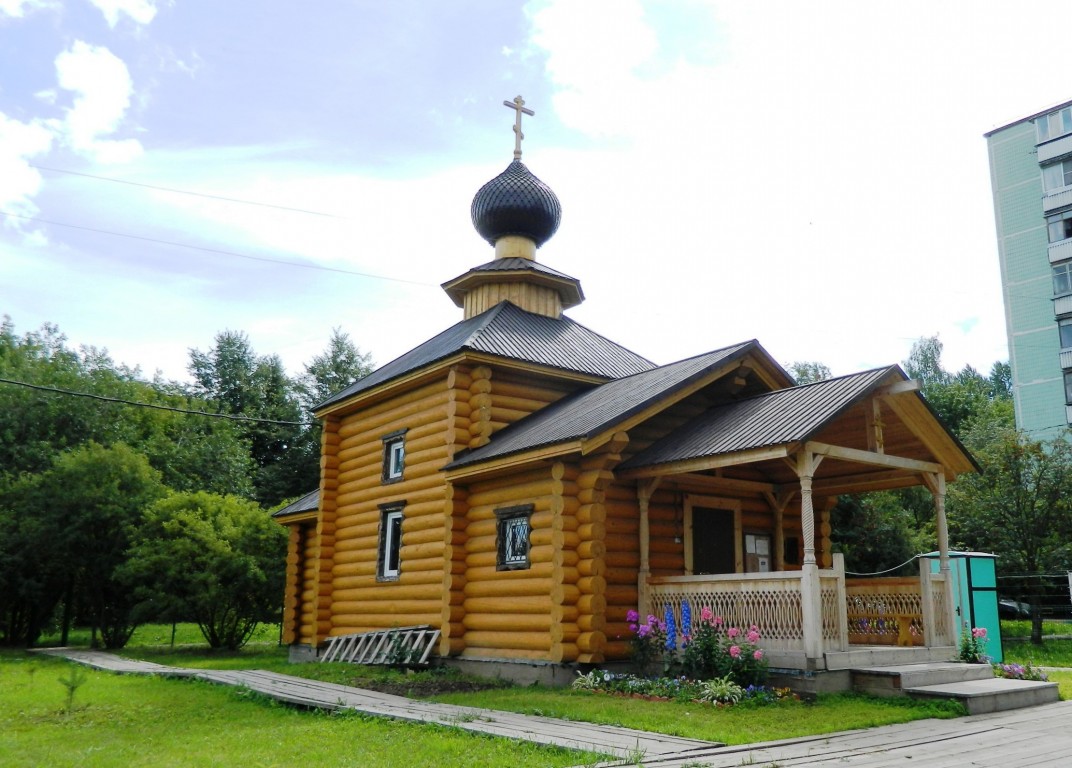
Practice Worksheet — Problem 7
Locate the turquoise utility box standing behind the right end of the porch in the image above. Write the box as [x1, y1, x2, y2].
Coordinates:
[922, 552, 1004, 663]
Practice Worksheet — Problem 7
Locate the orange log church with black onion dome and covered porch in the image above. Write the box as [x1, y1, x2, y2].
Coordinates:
[277, 97, 976, 673]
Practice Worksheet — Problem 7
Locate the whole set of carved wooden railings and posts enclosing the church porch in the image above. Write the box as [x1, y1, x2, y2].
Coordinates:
[644, 553, 957, 671]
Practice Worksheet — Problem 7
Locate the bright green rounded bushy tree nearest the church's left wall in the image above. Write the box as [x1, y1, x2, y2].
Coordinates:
[121, 492, 286, 649]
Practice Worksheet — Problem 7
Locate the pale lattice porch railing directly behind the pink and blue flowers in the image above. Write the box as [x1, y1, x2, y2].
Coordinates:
[649, 571, 847, 652]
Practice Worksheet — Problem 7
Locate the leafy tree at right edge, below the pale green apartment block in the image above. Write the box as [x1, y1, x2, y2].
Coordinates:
[949, 431, 1072, 643]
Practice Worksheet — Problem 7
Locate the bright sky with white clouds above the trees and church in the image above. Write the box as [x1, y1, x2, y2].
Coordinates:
[0, 0, 1072, 381]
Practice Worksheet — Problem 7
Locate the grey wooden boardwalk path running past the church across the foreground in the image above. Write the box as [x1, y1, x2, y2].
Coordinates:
[37, 649, 1072, 768]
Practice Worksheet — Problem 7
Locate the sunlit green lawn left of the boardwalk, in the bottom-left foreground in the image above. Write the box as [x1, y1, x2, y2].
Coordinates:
[0, 651, 595, 768]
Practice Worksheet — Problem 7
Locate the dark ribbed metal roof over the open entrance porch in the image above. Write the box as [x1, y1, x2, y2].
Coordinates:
[619, 366, 908, 470]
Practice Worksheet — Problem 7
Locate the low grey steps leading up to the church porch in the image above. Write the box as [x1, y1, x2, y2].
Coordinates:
[851, 662, 1059, 714]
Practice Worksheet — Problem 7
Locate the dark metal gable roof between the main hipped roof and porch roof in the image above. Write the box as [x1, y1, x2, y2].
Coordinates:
[447, 340, 759, 469]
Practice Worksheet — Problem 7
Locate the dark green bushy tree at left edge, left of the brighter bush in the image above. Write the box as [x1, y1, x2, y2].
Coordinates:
[0, 443, 163, 648]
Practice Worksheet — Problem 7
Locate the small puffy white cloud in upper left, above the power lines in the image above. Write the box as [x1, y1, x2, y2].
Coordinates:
[53, 40, 142, 163]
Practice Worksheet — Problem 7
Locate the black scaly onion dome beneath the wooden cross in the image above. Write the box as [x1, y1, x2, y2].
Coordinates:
[472, 160, 562, 248]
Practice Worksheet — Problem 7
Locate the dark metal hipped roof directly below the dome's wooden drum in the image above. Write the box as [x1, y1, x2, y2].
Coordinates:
[316, 301, 655, 411]
